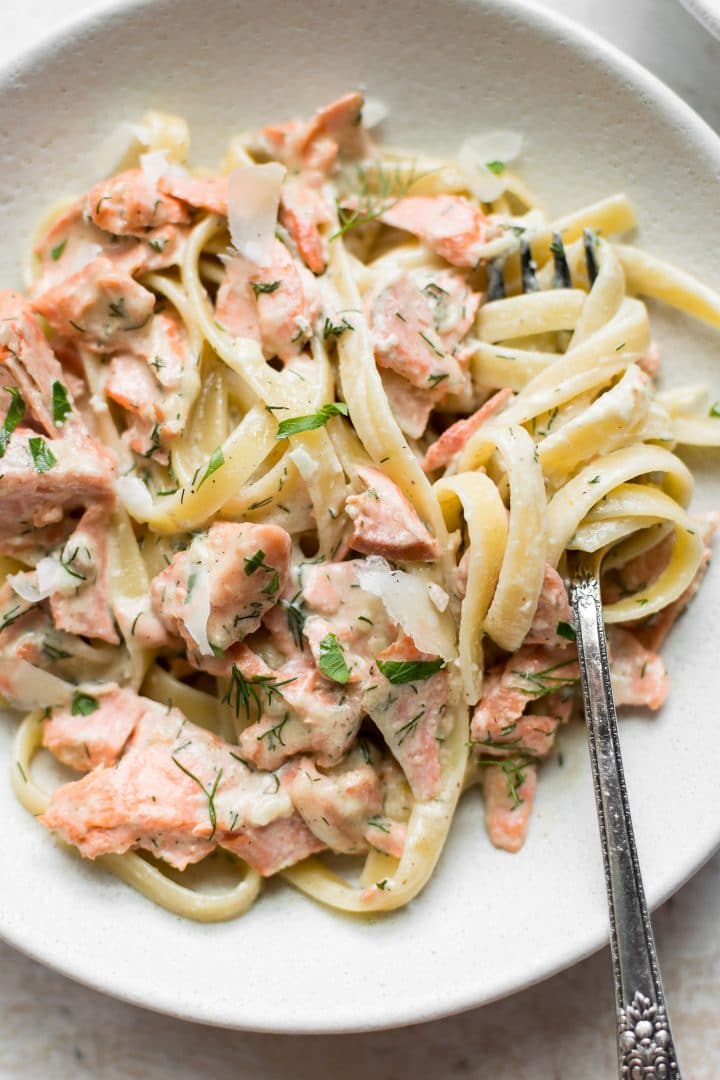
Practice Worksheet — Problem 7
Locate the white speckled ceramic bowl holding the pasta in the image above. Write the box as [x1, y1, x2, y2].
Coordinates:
[0, 0, 720, 1031]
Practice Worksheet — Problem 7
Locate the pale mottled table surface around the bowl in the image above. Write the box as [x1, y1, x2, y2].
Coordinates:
[0, 0, 720, 1080]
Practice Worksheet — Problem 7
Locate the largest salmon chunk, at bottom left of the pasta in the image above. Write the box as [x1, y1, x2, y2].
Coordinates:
[40, 691, 322, 874]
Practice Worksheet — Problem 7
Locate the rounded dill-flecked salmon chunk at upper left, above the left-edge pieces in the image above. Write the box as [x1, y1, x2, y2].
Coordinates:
[32, 255, 155, 353]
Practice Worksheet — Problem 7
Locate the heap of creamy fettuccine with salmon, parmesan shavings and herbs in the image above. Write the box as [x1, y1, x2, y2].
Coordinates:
[0, 93, 720, 921]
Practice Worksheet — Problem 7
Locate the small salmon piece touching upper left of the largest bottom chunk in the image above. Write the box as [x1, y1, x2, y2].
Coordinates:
[42, 683, 144, 772]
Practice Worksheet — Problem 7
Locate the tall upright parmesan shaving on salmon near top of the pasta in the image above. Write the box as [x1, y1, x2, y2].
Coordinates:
[228, 161, 285, 262]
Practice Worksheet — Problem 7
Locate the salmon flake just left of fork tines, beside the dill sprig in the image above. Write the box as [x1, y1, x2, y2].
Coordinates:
[380, 195, 498, 267]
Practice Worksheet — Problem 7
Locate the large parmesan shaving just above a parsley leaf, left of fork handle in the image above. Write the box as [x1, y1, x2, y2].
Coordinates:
[357, 555, 458, 660]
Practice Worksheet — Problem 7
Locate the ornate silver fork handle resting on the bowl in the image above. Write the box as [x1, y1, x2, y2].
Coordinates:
[570, 576, 680, 1080]
